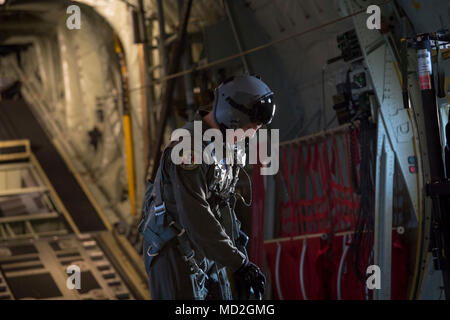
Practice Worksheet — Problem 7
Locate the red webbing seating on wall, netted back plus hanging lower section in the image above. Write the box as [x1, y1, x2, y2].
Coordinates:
[265, 130, 370, 299]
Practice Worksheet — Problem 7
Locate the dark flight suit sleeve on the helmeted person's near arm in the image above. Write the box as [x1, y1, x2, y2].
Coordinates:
[166, 149, 246, 272]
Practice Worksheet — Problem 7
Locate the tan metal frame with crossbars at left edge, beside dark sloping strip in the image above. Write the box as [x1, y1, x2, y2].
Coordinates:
[0, 140, 74, 241]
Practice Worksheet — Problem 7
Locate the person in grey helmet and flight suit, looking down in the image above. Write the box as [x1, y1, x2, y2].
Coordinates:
[140, 75, 275, 300]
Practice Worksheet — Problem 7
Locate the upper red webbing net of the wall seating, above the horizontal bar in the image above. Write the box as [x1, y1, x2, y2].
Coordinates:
[280, 130, 360, 236]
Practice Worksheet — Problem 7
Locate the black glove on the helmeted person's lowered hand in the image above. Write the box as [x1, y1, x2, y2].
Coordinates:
[234, 260, 266, 300]
